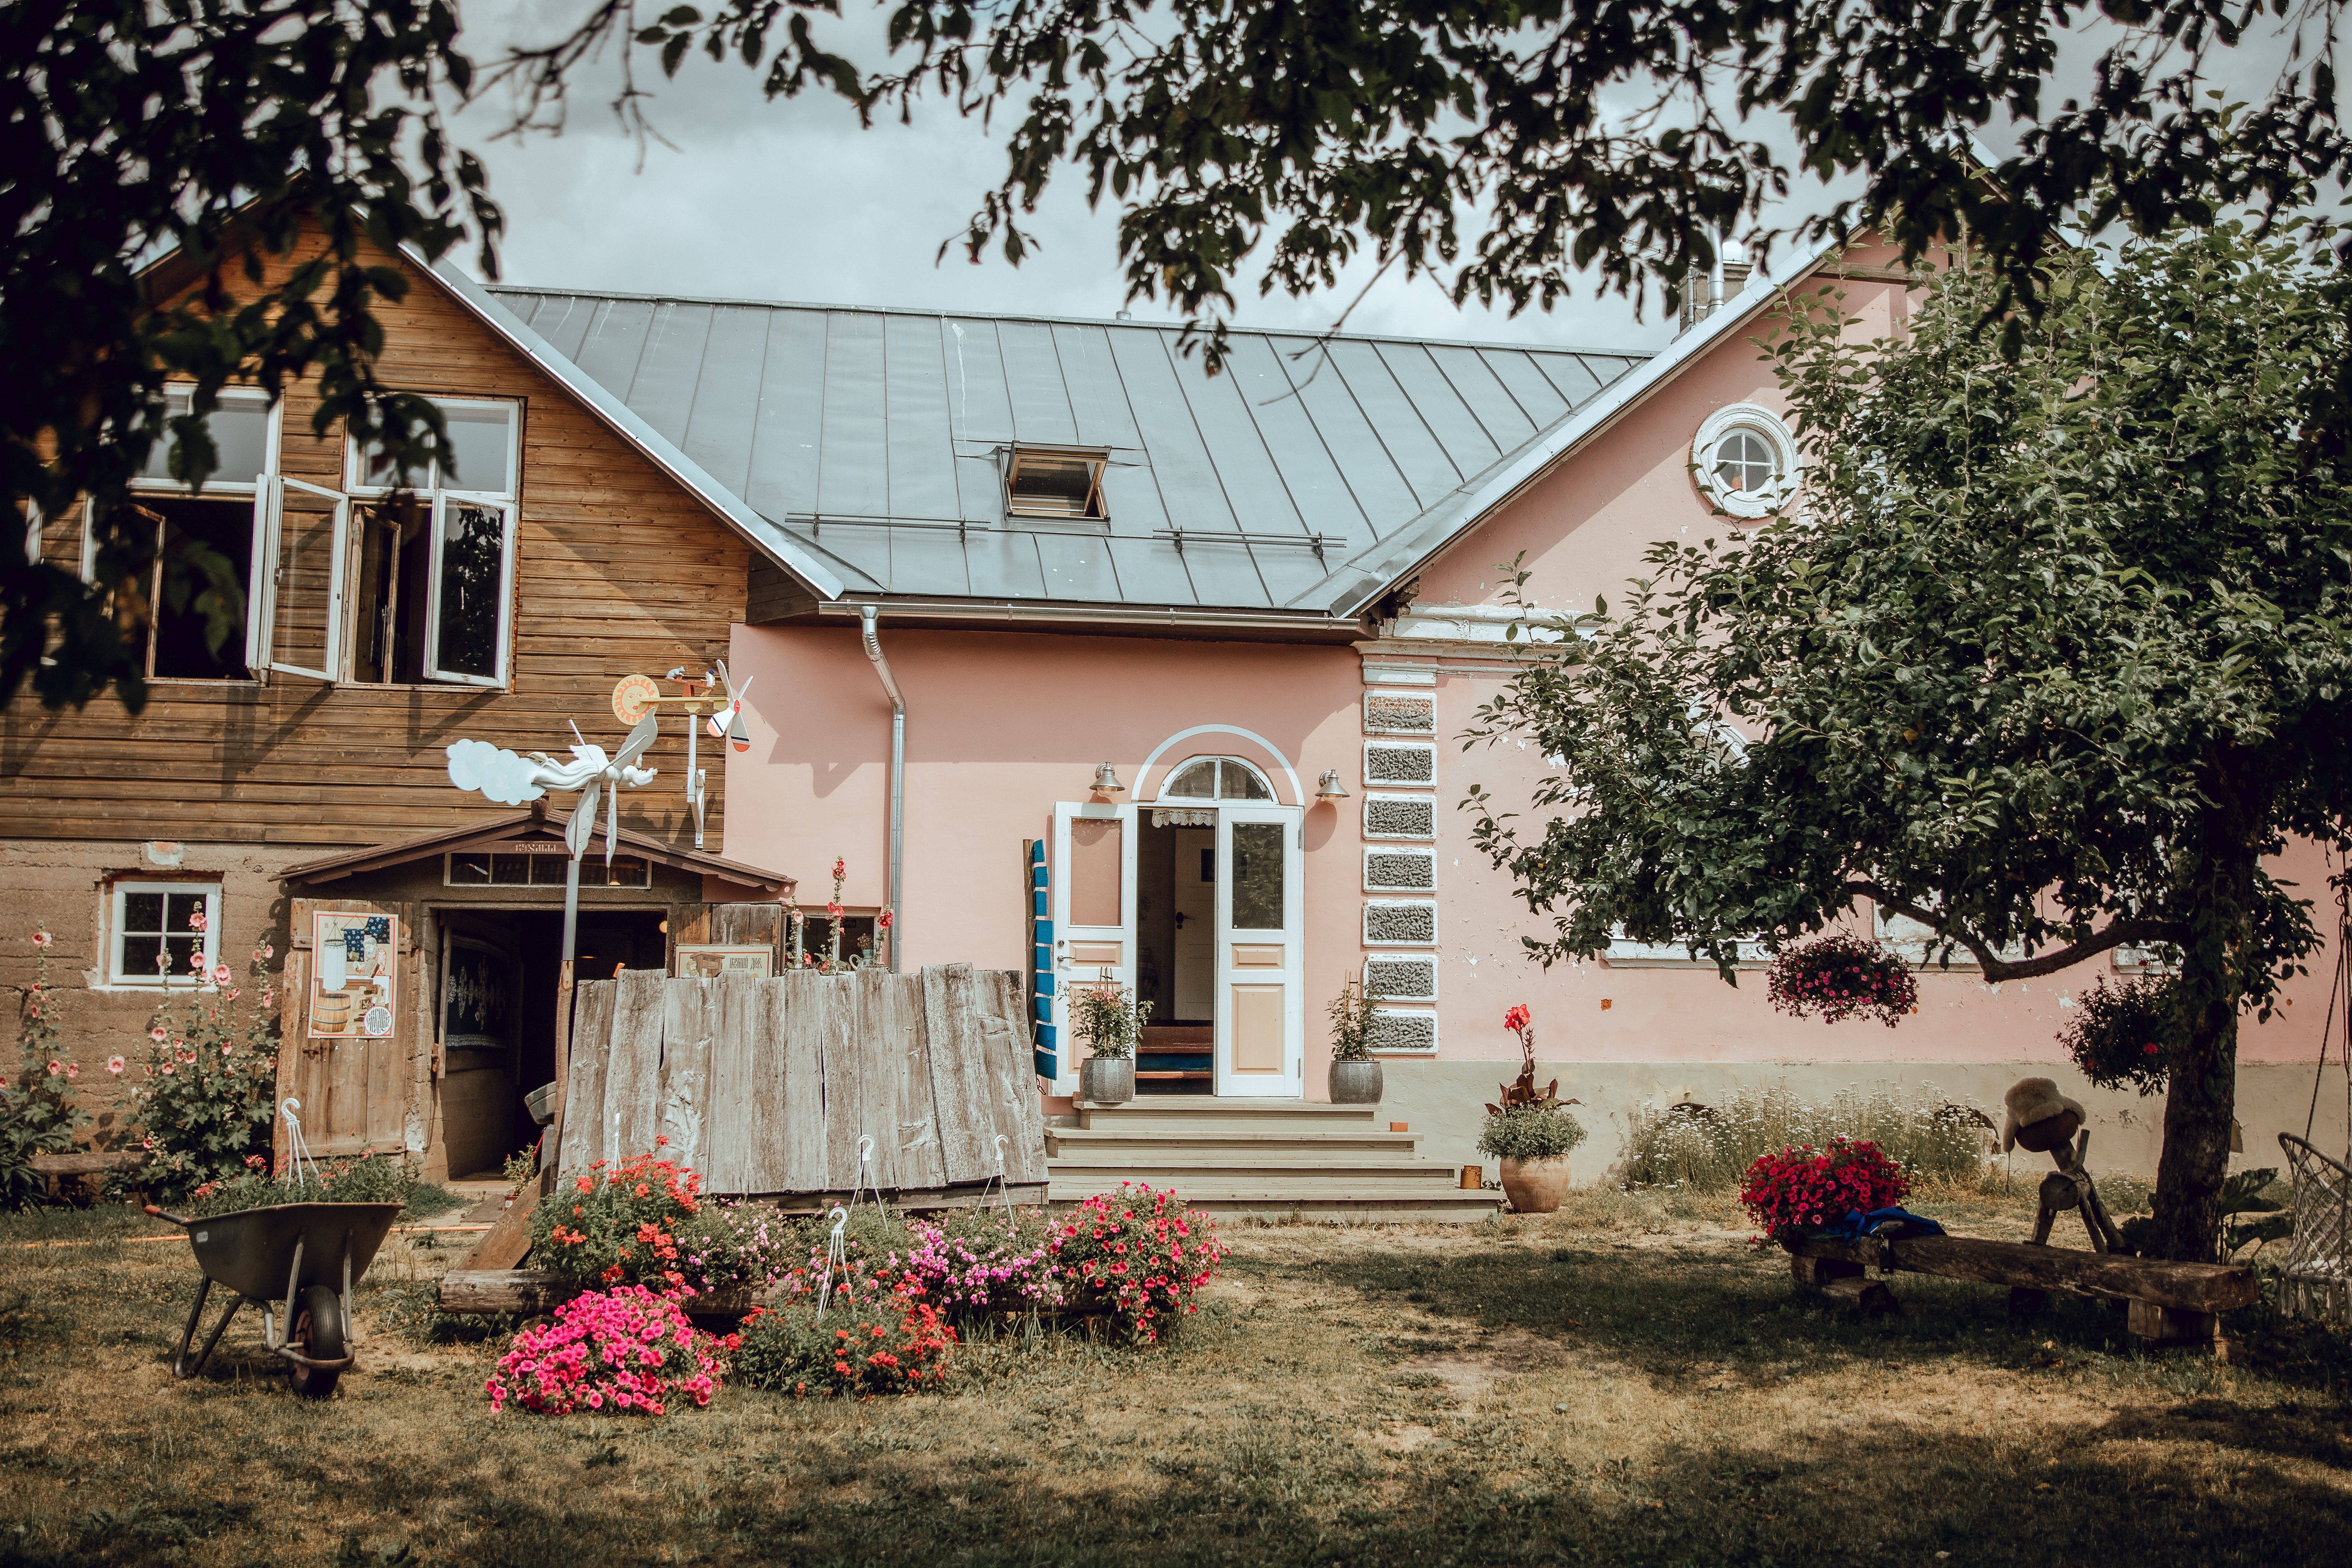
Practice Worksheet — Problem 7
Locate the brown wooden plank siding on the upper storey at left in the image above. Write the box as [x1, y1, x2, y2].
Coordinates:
[0, 227, 750, 851]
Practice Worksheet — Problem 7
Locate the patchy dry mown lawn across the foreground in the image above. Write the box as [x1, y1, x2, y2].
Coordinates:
[0, 1183, 2352, 1568]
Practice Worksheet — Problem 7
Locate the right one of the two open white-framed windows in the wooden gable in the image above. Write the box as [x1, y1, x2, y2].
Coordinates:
[343, 397, 522, 686]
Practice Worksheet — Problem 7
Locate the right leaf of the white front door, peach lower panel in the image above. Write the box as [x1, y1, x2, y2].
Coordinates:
[1216, 804, 1305, 1100]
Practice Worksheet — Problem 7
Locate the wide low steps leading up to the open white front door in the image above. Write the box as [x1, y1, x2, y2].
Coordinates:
[1047, 1095, 1498, 1223]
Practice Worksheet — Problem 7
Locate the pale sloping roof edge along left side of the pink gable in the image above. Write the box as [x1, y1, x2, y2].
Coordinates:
[1284, 235, 1853, 616]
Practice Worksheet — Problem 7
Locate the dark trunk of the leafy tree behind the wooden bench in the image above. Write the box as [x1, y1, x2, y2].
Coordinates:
[2152, 764, 2263, 1263]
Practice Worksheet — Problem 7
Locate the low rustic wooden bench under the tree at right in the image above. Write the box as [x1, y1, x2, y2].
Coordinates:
[1783, 1237, 2263, 1349]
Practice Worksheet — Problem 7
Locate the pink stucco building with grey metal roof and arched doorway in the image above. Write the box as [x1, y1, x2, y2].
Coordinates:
[487, 249, 2342, 1178]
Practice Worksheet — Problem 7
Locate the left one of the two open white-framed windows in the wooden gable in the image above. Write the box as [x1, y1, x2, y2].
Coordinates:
[115, 388, 278, 679]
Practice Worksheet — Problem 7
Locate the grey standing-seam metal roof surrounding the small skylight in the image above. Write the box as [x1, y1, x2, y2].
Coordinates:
[494, 287, 1646, 613]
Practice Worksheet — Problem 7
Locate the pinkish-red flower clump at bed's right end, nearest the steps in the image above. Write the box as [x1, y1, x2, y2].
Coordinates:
[1049, 1183, 1226, 1345]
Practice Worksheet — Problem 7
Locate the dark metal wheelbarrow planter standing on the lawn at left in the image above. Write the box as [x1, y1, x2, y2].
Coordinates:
[146, 1204, 400, 1399]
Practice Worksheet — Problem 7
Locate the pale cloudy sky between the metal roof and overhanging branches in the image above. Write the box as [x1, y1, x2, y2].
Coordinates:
[444, 0, 1670, 348]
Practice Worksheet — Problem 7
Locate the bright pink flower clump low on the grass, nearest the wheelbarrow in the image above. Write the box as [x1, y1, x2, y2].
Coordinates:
[482, 1286, 739, 1415]
